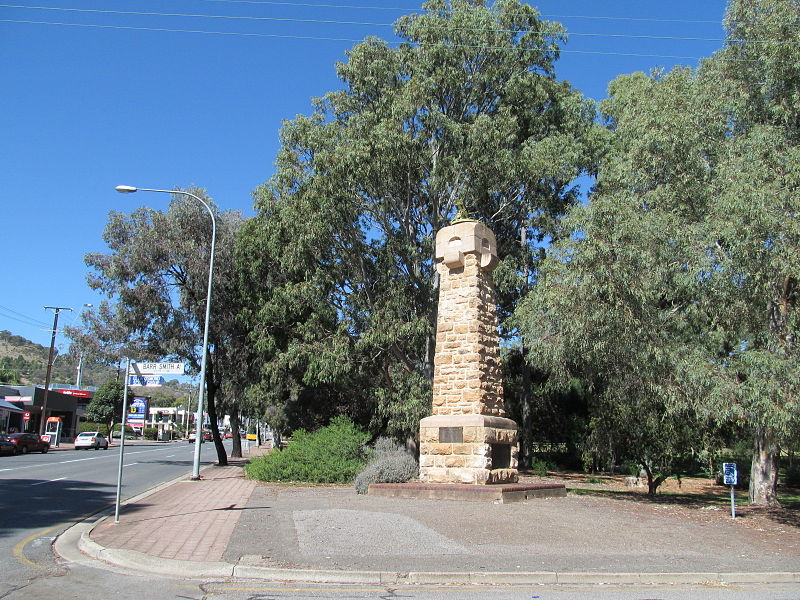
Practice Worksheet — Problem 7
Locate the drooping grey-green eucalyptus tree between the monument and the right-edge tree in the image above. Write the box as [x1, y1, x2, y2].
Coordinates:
[516, 69, 724, 494]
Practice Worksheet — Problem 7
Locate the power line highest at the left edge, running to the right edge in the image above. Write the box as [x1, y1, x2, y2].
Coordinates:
[0, 4, 800, 44]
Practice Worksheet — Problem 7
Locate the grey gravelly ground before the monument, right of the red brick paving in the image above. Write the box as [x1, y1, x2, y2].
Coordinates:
[225, 484, 800, 572]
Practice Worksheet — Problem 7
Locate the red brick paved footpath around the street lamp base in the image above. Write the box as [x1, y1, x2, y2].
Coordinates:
[91, 453, 256, 562]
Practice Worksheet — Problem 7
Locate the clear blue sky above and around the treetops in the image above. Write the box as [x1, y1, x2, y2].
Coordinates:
[0, 0, 726, 354]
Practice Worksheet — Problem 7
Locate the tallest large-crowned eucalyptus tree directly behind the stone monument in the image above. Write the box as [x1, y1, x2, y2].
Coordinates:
[240, 0, 594, 437]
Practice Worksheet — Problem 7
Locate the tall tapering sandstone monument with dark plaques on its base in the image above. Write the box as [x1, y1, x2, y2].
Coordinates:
[420, 219, 518, 484]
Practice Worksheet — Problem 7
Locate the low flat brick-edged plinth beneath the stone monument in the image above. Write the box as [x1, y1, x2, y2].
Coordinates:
[367, 482, 567, 504]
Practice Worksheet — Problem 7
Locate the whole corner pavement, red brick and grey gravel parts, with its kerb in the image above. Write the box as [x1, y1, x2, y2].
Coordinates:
[67, 449, 800, 584]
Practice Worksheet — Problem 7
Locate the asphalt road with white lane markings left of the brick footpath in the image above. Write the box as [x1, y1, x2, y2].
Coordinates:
[0, 442, 225, 598]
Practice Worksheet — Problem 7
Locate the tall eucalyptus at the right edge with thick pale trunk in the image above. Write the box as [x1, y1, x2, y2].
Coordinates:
[706, 0, 800, 504]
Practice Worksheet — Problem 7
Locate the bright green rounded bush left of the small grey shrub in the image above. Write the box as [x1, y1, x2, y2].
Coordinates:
[245, 416, 369, 483]
